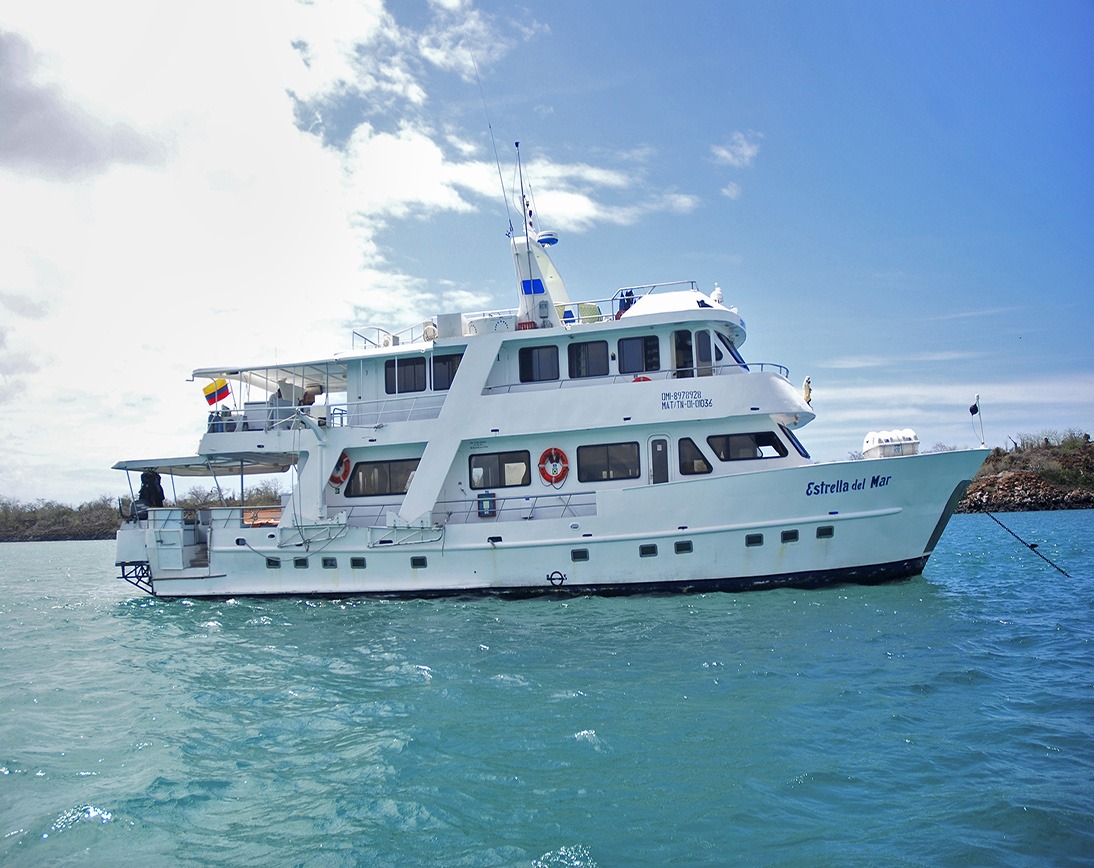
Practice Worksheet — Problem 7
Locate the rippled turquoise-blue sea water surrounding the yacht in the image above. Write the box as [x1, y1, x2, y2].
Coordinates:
[0, 511, 1094, 866]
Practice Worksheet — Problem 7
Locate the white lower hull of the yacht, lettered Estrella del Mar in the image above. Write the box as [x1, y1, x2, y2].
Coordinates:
[119, 450, 987, 597]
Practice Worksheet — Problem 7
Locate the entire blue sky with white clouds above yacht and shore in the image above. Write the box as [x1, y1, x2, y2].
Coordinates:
[0, 0, 1094, 505]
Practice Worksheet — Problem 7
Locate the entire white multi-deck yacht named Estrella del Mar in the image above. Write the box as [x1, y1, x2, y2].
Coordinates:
[115, 195, 988, 597]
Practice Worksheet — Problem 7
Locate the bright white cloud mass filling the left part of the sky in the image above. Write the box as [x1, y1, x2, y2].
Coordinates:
[0, 0, 697, 501]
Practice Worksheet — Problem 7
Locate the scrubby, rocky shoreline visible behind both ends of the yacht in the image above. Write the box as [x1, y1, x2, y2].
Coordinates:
[0, 429, 1094, 542]
